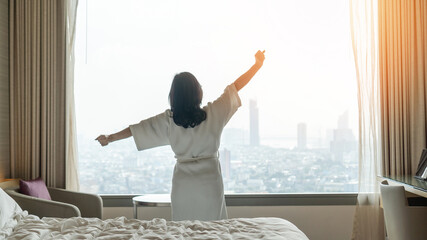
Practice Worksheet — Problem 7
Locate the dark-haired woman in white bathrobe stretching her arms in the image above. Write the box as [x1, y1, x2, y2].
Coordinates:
[96, 51, 265, 221]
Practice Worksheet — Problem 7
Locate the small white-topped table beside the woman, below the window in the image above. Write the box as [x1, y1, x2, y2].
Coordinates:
[132, 194, 171, 219]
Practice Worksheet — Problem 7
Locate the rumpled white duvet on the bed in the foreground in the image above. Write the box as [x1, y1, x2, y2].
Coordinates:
[0, 211, 308, 240]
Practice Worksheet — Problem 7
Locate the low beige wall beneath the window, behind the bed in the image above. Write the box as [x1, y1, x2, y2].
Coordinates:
[104, 205, 355, 240]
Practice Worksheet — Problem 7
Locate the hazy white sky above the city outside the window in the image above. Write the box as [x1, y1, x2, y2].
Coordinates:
[75, 0, 357, 142]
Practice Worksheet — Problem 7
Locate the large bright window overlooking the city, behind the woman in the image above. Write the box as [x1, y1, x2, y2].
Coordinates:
[75, 0, 358, 194]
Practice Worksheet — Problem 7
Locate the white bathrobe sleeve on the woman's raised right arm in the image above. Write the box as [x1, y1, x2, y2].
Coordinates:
[208, 83, 242, 127]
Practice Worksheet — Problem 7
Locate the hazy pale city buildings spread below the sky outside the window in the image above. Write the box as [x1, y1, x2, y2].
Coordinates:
[79, 109, 358, 194]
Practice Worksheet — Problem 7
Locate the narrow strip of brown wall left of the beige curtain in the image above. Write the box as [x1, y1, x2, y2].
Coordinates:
[0, 0, 10, 179]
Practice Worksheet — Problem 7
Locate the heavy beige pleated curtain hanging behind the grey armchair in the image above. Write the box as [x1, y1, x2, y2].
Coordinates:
[9, 0, 66, 188]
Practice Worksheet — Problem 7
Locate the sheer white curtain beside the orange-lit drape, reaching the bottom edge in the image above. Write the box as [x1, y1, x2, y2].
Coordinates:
[350, 0, 384, 240]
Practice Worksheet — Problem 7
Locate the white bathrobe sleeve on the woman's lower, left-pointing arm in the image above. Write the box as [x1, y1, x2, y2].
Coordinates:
[129, 110, 171, 151]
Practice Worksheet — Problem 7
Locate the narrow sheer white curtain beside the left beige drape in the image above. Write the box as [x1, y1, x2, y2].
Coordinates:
[65, 0, 79, 191]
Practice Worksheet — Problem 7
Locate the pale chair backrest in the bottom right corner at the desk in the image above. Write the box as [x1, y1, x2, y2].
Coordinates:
[380, 181, 427, 240]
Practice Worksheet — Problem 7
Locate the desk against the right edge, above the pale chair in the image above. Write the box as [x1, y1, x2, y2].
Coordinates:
[377, 176, 427, 198]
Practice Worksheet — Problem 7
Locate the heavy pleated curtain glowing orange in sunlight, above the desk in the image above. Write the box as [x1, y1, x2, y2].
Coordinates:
[378, 0, 427, 176]
